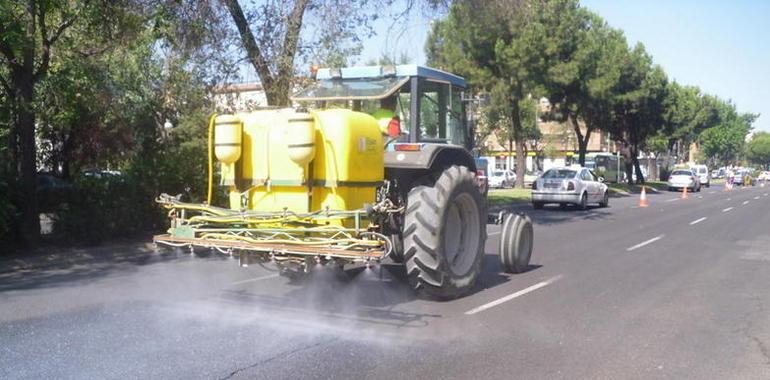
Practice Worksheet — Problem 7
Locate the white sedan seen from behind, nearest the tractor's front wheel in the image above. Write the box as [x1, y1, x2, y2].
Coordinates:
[532, 167, 610, 210]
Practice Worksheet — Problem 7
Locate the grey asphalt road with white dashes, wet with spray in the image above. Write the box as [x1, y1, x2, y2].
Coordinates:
[0, 186, 770, 379]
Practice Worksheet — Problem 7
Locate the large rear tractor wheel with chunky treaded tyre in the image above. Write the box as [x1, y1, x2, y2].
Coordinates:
[403, 166, 487, 300]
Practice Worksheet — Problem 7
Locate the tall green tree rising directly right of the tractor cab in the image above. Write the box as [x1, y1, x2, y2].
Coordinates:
[426, 0, 552, 186]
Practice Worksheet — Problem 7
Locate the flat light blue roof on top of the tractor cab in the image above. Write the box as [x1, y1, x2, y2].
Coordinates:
[316, 65, 466, 88]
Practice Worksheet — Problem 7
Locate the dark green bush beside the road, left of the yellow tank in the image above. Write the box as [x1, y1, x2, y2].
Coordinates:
[54, 112, 213, 244]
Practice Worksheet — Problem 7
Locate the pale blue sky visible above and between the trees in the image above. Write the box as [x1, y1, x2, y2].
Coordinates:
[361, 0, 770, 132]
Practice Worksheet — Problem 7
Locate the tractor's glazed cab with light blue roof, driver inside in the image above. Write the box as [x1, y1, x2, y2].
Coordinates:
[292, 65, 472, 150]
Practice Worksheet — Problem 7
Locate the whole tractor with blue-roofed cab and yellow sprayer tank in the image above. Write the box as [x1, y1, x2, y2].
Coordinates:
[154, 65, 533, 300]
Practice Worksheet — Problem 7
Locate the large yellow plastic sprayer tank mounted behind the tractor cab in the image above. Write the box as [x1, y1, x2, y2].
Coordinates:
[215, 109, 384, 220]
